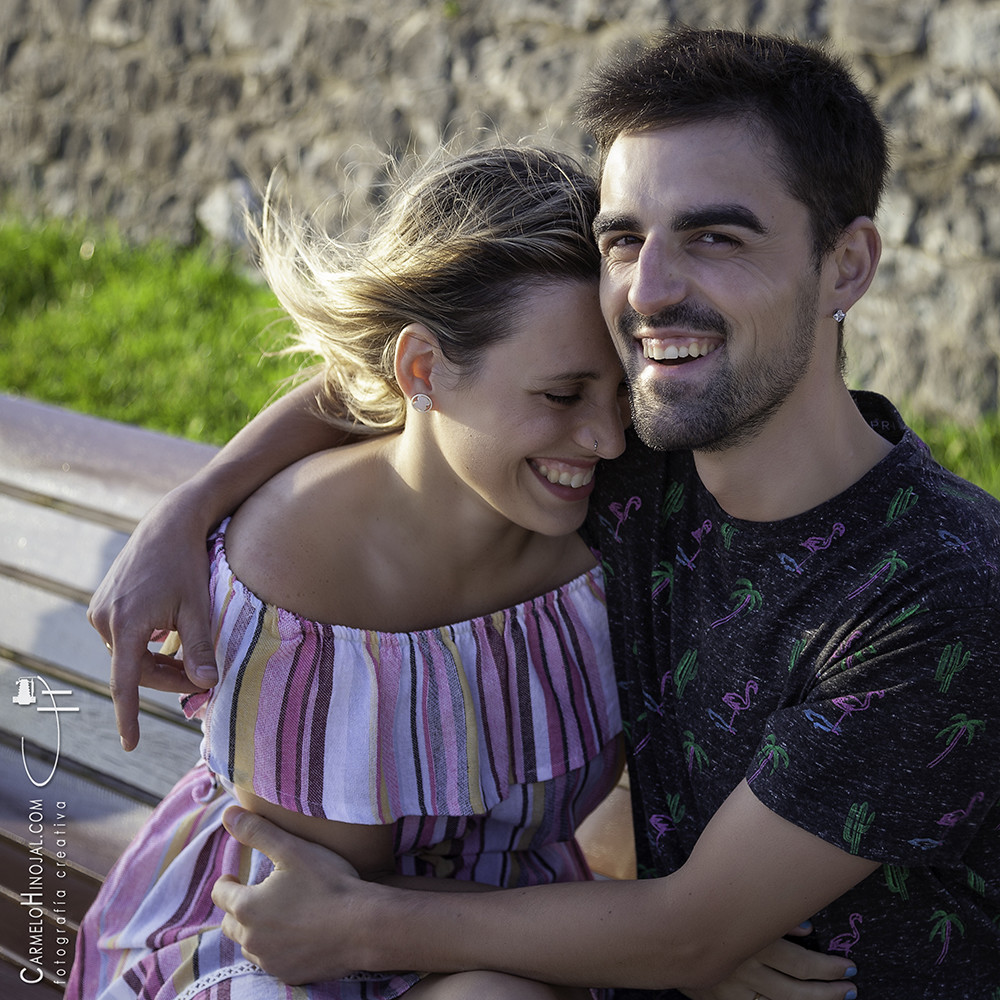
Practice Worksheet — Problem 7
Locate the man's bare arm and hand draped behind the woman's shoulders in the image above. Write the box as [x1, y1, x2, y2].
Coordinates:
[88, 378, 352, 750]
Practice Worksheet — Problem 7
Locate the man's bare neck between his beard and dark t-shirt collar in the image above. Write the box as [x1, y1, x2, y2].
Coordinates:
[694, 380, 892, 521]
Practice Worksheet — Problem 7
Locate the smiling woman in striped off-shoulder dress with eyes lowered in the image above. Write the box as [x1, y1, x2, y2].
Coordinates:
[67, 147, 624, 1000]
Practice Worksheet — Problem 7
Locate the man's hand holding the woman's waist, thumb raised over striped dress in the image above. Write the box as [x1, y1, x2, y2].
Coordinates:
[212, 806, 368, 986]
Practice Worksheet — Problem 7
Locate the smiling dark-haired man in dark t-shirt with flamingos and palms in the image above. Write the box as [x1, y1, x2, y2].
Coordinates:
[88, 23, 1000, 1000]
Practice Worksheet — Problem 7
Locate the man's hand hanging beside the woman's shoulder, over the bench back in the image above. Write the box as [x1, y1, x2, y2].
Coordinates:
[87, 491, 218, 750]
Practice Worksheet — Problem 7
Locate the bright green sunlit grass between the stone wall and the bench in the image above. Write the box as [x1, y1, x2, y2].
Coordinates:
[0, 221, 1000, 496]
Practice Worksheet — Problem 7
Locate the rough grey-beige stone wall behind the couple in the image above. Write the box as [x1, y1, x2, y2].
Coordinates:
[0, 0, 1000, 419]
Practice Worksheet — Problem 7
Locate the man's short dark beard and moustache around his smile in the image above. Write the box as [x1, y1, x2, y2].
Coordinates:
[617, 278, 819, 451]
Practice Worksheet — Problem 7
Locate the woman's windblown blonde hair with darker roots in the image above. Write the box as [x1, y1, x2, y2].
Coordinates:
[251, 146, 599, 430]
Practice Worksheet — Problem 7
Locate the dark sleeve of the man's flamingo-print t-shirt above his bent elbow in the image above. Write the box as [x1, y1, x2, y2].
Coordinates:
[747, 608, 1000, 865]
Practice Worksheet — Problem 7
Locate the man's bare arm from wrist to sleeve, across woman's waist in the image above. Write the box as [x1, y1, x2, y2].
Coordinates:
[347, 783, 878, 989]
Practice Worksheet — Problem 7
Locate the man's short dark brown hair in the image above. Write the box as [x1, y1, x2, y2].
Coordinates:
[578, 27, 889, 258]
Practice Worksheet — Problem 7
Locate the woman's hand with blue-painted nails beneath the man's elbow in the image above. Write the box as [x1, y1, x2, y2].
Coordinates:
[682, 924, 857, 1000]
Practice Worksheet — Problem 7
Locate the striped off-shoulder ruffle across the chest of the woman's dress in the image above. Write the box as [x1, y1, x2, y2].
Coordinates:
[185, 522, 621, 824]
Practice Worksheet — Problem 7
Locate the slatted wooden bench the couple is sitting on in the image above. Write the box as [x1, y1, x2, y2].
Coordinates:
[0, 395, 634, 1000]
